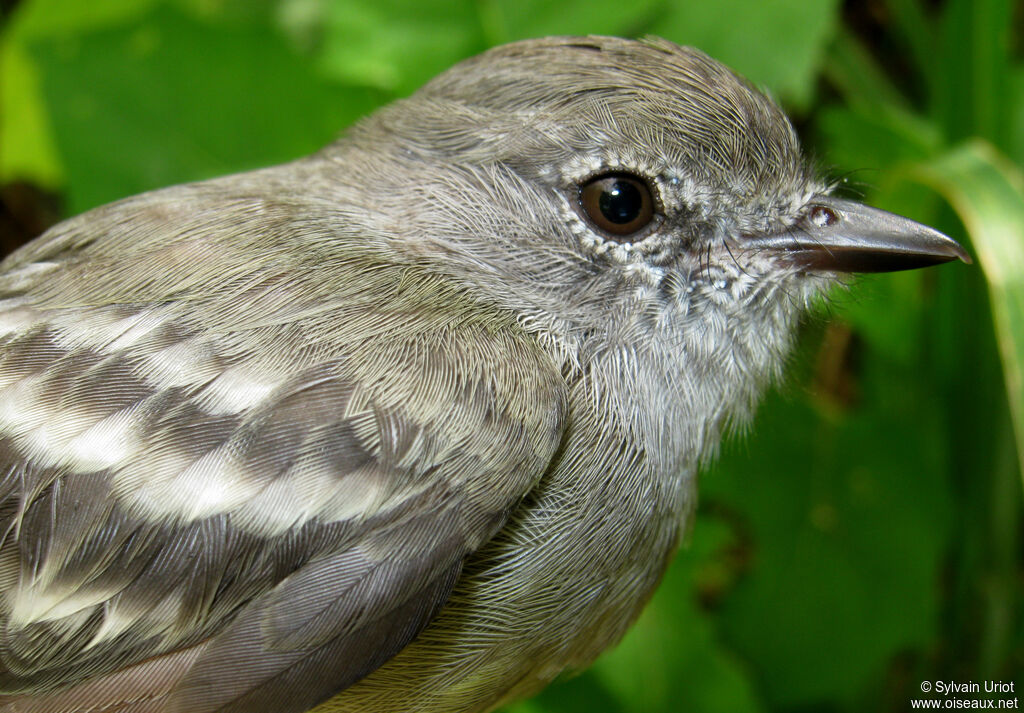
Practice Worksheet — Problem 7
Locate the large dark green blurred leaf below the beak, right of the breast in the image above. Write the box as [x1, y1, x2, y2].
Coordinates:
[701, 379, 951, 710]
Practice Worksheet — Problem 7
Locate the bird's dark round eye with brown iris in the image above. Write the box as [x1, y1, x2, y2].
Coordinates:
[580, 173, 654, 242]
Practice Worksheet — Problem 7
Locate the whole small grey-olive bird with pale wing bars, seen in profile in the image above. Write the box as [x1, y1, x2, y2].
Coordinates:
[0, 37, 968, 713]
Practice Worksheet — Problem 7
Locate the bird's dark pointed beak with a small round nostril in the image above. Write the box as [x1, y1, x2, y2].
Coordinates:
[741, 196, 971, 272]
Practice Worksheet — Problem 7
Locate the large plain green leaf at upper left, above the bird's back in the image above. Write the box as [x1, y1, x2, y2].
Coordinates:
[31, 6, 385, 212]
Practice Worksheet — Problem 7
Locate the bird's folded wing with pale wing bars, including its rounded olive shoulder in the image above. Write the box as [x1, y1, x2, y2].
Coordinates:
[0, 192, 565, 713]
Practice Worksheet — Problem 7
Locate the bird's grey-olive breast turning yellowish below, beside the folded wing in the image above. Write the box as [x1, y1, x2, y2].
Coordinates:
[316, 358, 694, 713]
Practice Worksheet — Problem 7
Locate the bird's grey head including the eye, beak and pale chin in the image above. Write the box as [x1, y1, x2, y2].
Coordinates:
[313, 37, 968, 434]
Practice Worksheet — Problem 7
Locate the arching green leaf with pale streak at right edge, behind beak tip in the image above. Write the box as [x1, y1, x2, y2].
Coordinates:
[910, 139, 1024, 485]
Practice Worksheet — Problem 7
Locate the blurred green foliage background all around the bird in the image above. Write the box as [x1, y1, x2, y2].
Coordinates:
[0, 0, 1024, 713]
